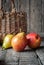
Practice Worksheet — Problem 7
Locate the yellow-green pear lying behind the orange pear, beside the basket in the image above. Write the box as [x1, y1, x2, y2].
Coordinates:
[2, 34, 13, 49]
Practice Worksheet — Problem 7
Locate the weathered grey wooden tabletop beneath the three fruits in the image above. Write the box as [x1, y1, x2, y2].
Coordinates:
[0, 42, 44, 65]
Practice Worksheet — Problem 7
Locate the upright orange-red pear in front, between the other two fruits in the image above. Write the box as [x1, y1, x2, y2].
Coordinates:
[11, 32, 27, 51]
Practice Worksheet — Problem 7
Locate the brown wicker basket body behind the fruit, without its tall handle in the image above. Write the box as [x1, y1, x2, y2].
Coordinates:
[0, 8, 27, 39]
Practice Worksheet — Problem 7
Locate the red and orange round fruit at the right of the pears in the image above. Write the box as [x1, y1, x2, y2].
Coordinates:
[26, 33, 41, 49]
